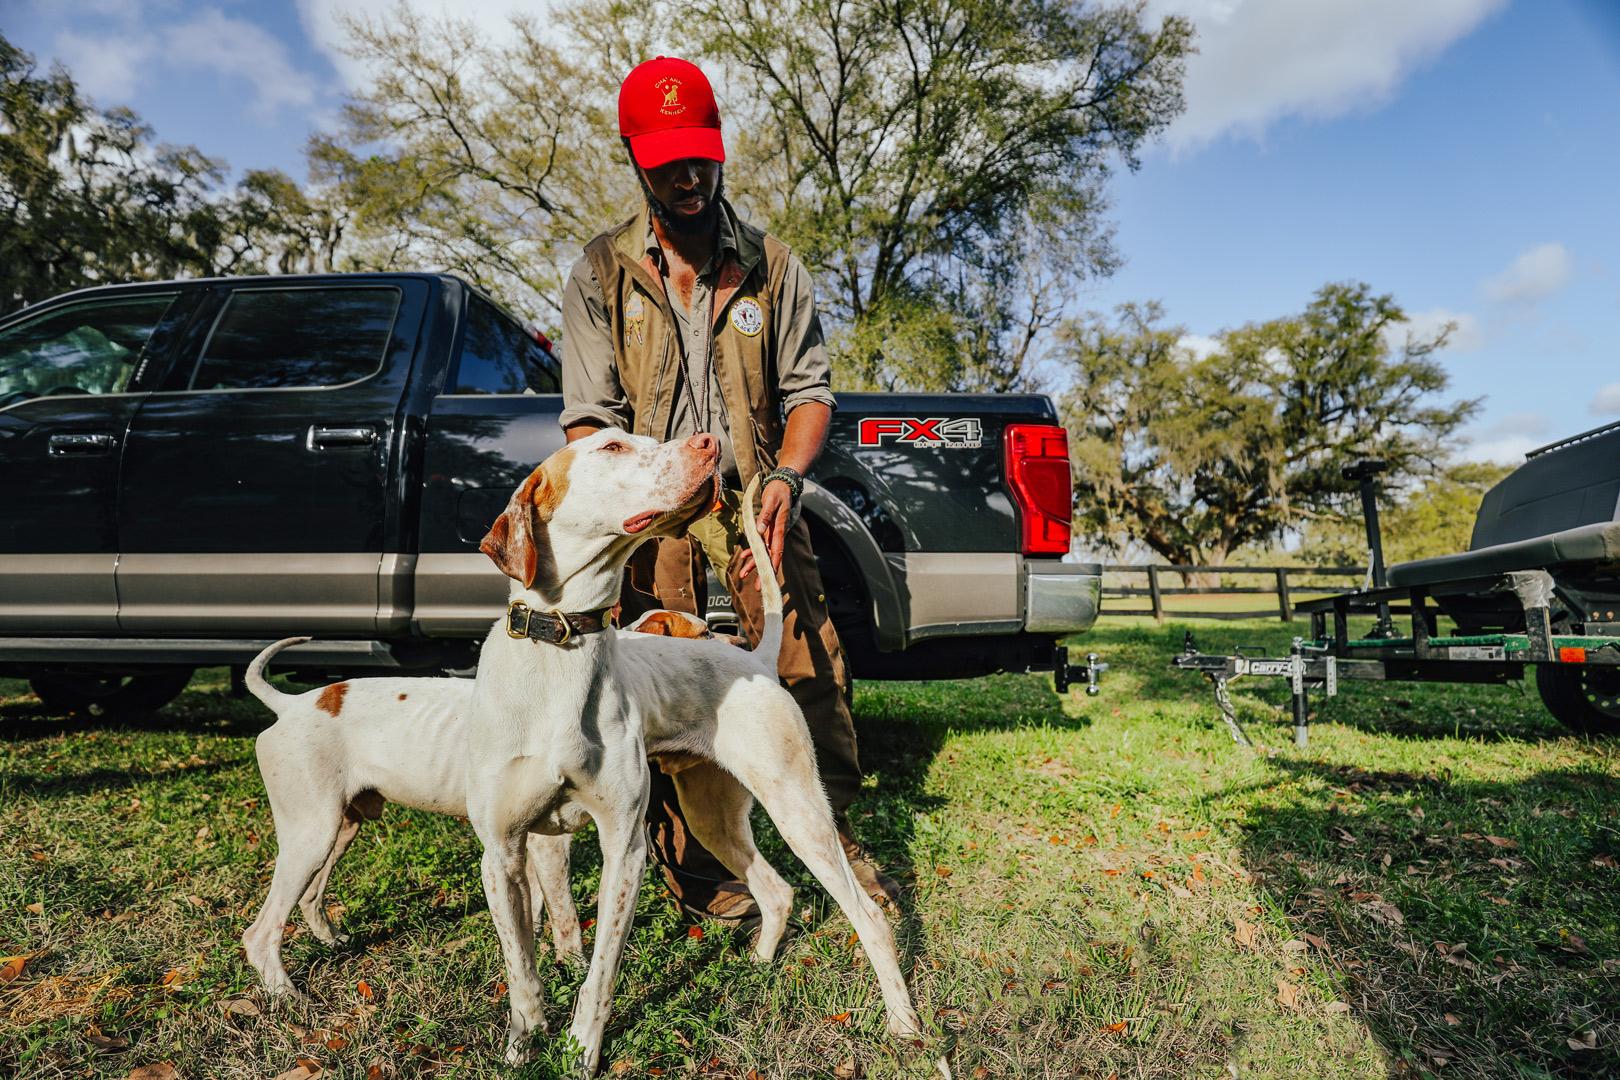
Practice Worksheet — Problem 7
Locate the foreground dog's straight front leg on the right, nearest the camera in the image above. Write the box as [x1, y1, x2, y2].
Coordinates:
[569, 773, 648, 1077]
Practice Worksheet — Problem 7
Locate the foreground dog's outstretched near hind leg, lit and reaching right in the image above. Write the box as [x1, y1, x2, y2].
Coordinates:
[714, 705, 922, 1036]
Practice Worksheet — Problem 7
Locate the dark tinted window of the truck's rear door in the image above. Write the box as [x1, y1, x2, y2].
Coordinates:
[191, 288, 400, 390]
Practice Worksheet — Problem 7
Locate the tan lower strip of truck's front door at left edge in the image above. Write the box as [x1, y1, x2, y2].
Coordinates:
[0, 552, 118, 633]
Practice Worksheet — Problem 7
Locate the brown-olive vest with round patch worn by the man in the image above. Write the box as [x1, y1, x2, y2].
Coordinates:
[585, 199, 789, 486]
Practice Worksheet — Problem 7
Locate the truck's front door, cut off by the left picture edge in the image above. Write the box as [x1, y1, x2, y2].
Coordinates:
[0, 288, 194, 635]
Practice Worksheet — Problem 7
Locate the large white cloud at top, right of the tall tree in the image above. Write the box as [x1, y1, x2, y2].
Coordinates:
[1149, 0, 1507, 151]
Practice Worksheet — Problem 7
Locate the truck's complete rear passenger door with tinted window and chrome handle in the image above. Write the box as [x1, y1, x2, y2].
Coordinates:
[118, 279, 429, 636]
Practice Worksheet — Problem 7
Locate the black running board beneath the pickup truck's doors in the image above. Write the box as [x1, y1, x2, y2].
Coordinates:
[0, 638, 400, 667]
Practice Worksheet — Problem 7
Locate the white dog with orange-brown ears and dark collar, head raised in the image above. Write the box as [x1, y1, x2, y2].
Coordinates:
[465, 429, 949, 1075]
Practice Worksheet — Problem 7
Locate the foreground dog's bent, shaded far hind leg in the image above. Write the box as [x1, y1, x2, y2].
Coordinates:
[676, 763, 794, 962]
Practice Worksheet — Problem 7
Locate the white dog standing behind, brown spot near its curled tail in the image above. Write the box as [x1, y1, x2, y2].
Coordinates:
[241, 641, 589, 994]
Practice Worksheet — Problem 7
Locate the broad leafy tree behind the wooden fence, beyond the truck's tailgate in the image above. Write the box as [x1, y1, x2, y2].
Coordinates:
[1059, 283, 1477, 565]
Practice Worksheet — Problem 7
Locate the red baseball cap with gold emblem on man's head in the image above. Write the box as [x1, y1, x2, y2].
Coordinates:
[619, 57, 726, 168]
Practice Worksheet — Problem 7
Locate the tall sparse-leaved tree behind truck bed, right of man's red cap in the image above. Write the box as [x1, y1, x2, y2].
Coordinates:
[682, 0, 1192, 390]
